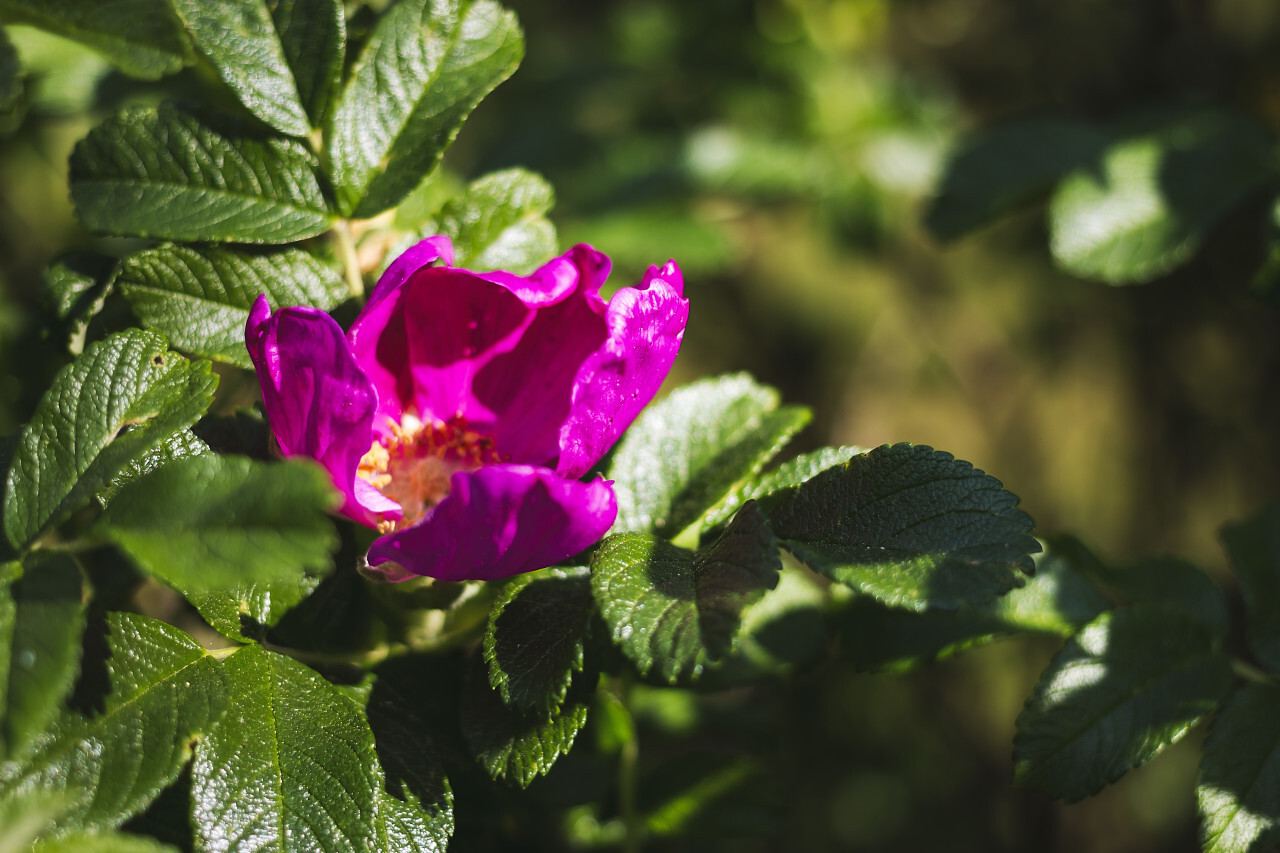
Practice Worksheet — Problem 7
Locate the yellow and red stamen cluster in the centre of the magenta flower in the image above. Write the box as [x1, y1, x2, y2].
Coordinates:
[356, 415, 503, 533]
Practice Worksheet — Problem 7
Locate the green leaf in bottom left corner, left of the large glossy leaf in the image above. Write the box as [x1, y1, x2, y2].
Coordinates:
[0, 613, 227, 833]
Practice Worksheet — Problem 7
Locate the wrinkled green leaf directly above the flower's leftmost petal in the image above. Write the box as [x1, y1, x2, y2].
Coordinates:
[115, 245, 347, 368]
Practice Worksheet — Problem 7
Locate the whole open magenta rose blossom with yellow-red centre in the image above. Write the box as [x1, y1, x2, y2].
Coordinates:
[244, 237, 689, 580]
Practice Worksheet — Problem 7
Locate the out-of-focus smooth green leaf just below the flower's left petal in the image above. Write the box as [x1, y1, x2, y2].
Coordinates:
[97, 456, 338, 593]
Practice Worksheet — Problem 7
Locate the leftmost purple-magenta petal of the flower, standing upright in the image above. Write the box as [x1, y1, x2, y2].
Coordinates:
[244, 296, 399, 524]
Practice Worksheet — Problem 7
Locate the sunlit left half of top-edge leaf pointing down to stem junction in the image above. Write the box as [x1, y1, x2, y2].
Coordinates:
[172, 0, 311, 137]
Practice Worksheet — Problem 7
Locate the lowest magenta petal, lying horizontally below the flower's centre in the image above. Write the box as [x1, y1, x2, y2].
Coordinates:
[369, 465, 618, 580]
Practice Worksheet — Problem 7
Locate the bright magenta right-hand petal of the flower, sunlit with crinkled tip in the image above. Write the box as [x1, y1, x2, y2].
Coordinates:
[556, 267, 689, 479]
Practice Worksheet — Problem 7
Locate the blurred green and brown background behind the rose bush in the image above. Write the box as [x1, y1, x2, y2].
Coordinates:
[0, 0, 1280, 853]
